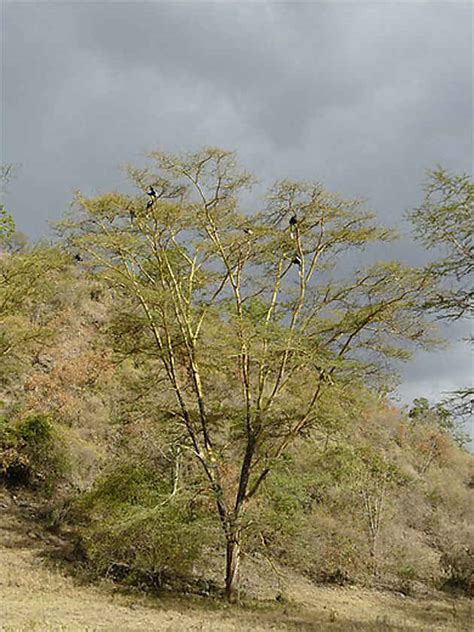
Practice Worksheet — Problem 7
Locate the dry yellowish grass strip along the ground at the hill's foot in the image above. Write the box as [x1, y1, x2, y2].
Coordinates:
[0, 494, 472, 632]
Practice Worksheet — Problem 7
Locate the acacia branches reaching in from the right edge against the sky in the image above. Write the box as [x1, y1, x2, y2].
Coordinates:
[408, 167, 474, 416]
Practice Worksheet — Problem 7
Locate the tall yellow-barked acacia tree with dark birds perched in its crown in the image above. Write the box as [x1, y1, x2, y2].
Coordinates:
[60, 149, 431, 602]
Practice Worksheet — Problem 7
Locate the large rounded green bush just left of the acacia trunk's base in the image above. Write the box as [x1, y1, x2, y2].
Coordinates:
[70, 463, 218, 587]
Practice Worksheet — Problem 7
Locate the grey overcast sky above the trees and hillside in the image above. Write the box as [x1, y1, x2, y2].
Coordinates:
[1, 0, 473, 422]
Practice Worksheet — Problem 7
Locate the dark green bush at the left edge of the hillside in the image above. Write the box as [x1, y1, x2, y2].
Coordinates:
[0, 414, 69, 493]
